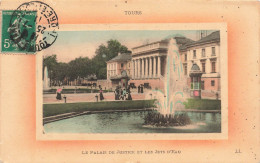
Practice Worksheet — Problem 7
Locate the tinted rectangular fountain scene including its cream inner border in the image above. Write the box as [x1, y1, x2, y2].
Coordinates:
[36, 23, 228, 140]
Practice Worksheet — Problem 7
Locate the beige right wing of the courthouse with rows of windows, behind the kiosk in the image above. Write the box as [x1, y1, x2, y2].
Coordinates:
[180, 31, 221, 98]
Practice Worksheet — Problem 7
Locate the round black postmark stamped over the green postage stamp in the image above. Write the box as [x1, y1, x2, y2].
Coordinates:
[2, 1, 59, 52]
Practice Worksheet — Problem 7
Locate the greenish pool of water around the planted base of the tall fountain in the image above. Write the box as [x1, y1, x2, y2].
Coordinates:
[44, 111, 221, 133]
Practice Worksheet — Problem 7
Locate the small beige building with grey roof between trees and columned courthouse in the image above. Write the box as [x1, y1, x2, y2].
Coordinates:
[107, 53, 132, 88]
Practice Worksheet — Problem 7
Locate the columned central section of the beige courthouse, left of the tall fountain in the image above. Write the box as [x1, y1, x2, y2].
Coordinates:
[131, 37, 192, 89]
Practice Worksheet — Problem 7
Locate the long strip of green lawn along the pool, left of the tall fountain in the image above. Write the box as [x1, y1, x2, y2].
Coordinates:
[43, 100, 154, 117]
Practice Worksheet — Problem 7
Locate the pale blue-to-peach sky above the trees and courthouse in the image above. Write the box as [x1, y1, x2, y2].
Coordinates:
[44, 30, 212, 62]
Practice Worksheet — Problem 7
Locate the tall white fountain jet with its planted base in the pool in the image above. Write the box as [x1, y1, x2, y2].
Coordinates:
[145, 38, 190, 126]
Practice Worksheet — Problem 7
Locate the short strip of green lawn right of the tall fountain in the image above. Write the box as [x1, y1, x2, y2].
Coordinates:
[183, 99, 221, 110]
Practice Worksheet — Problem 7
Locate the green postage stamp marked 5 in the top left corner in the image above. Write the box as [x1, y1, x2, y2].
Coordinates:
[1, 10, 37, 53]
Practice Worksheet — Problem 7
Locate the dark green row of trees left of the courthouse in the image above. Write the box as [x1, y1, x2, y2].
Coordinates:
[43, 39, 130, 83]
